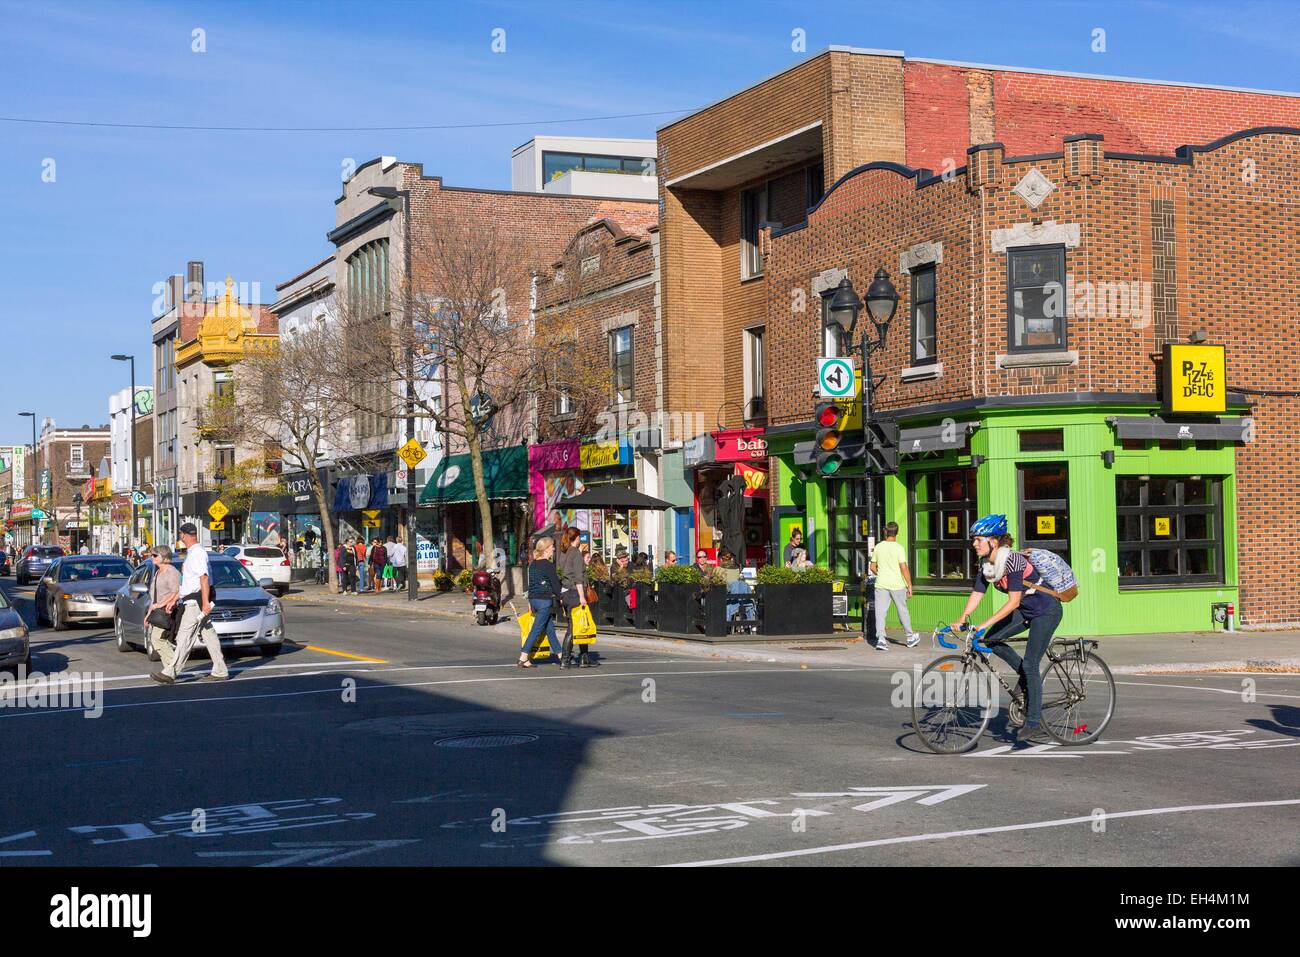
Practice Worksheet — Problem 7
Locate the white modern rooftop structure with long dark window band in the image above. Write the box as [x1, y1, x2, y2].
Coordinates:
[510, 137, 659, 199]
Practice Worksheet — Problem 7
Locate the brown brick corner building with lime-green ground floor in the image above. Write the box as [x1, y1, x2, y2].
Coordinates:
[659, 48, 1300, 633]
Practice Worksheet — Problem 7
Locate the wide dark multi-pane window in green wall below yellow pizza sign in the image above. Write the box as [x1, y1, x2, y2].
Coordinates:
[1115, 475, 1223, 588]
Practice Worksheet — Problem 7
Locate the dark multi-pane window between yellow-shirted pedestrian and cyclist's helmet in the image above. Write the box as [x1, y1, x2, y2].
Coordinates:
[907, 468, 976, 586]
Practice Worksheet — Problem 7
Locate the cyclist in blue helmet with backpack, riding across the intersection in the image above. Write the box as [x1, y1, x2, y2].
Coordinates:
[956, 515, 1062, 740]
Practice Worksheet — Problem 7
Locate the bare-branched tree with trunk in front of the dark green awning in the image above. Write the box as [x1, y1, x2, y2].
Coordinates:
[345, 217, 603, 559]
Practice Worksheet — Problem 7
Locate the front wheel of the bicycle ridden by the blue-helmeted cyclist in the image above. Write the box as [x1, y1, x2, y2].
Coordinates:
[911, 654, 996, 754]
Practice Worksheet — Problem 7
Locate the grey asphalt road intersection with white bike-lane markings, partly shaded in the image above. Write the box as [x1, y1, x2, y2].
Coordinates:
[0, 579, 1300, 867]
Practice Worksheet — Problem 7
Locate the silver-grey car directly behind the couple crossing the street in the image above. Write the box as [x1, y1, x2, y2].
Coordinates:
[113, 555, 285, 662]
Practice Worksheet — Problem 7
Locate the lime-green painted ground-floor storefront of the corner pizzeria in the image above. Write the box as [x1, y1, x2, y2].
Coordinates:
[768, 404, 1238, 635]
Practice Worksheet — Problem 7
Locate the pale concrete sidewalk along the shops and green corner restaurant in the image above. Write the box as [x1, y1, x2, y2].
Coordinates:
[285, 584, 1300, 675]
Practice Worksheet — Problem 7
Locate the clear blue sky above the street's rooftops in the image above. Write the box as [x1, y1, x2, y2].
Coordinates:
[0, 0, 1300, 442]
